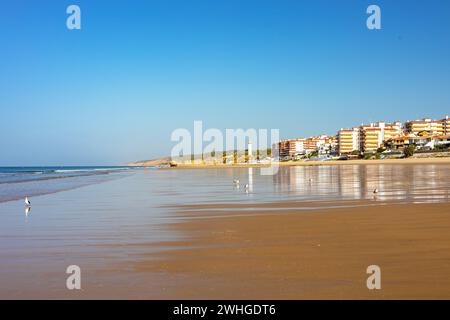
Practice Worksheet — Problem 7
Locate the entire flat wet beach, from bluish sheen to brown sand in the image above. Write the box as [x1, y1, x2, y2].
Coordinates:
[0, 163, 450, 299]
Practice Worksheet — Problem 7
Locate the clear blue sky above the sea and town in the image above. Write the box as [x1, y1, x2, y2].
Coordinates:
[0, 0, 450, 166]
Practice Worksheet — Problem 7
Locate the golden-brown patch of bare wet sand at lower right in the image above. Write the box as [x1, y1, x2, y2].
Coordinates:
[134, 202, 450, 299]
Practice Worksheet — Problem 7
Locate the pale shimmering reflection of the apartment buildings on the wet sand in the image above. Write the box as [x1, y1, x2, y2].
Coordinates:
[273, 165, 450, 203]
